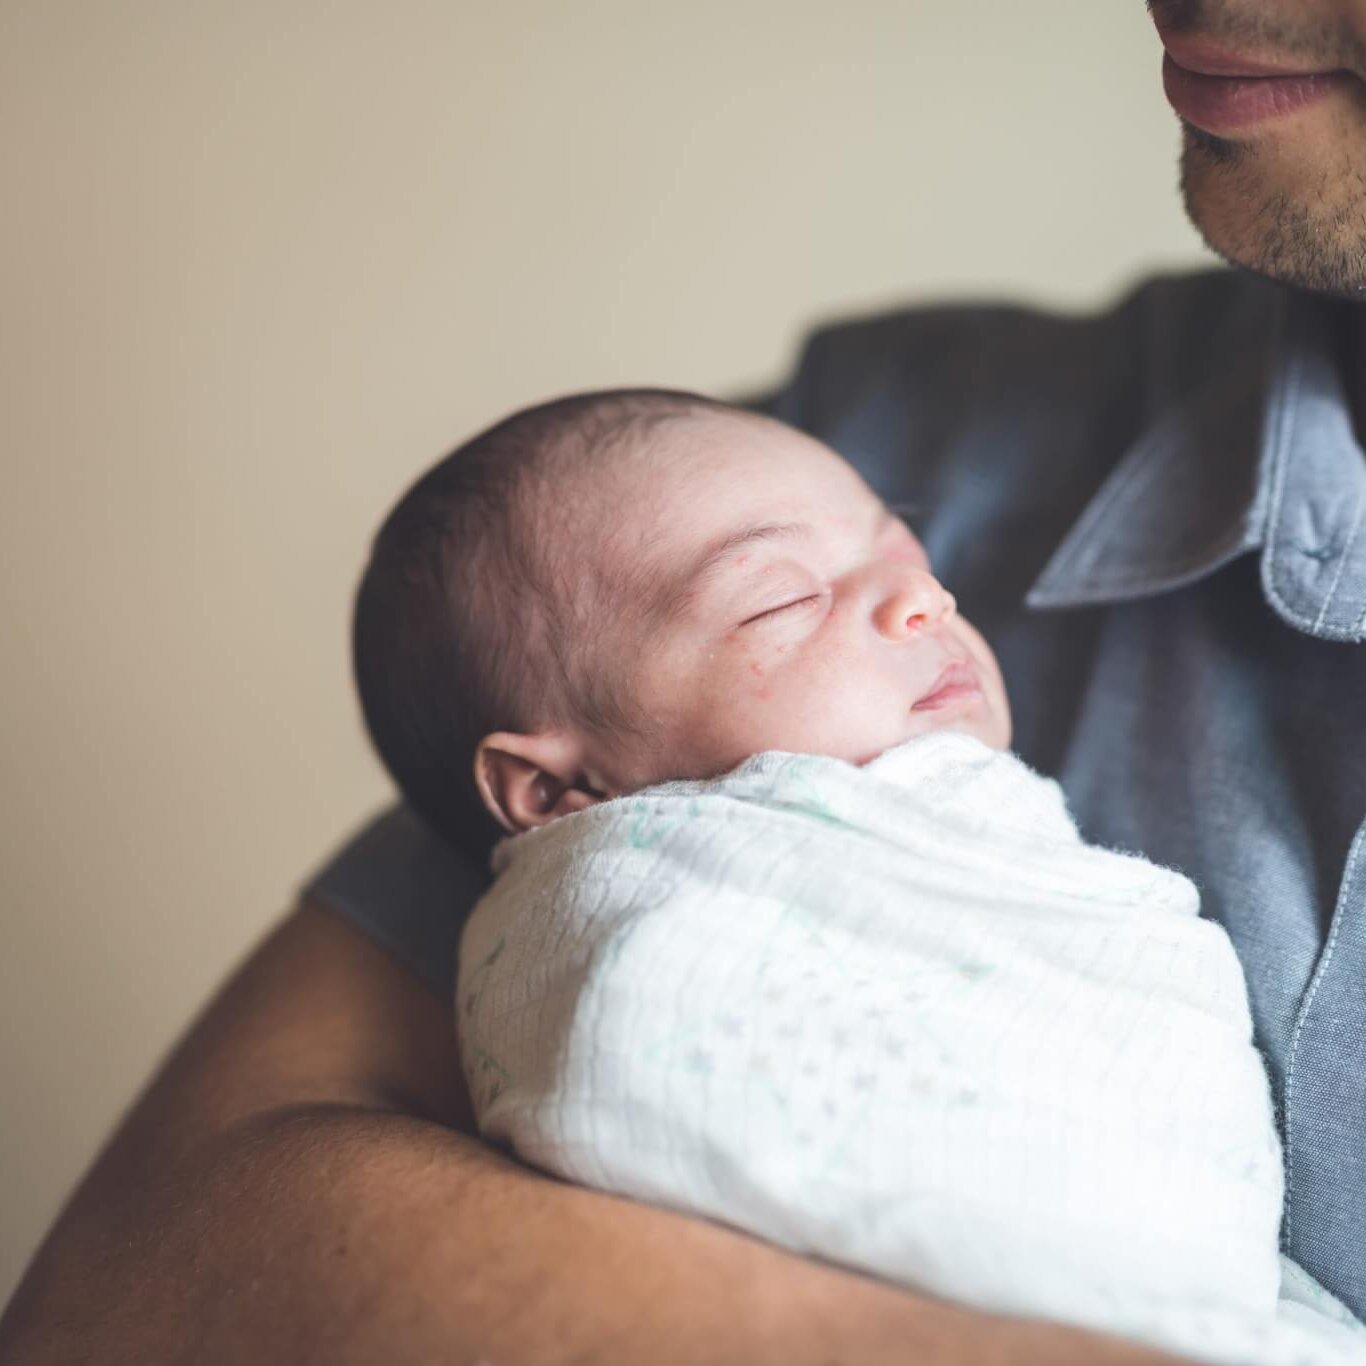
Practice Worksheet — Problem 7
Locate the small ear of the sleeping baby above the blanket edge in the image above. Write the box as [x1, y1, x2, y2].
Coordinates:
[474, 731, 609, 835]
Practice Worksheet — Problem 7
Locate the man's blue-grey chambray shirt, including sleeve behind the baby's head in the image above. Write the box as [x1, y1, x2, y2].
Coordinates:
[309, 272, 1366, 1317]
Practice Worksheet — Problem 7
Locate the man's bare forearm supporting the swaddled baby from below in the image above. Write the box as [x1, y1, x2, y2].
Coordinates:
[0, 1106, 1185, 1366]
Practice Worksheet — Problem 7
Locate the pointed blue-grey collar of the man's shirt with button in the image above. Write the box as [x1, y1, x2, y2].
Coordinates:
[1025, 290, 1366, 641]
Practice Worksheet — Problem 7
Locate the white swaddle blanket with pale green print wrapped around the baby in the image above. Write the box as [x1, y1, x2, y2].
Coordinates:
[458, 732, 1366, 1363]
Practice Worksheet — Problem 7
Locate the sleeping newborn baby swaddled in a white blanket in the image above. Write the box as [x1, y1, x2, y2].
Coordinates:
[355, 391, 1366, 1363]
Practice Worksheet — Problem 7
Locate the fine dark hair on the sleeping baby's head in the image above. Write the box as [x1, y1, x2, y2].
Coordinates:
[351, 389, 736, 866]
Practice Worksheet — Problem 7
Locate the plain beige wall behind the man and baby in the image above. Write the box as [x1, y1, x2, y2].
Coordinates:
[0, 0, 1202, 1300]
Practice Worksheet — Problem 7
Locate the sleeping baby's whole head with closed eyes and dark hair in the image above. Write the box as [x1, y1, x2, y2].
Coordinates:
[354, 389, 1011, 850]
